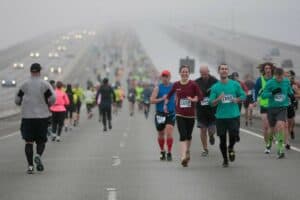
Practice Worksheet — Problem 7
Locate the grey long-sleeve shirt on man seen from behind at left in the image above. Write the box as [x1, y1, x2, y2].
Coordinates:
[15, 77, 56, 119]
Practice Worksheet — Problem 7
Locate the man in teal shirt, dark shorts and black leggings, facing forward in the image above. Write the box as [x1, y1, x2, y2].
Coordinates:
[209, 64, 246, 167]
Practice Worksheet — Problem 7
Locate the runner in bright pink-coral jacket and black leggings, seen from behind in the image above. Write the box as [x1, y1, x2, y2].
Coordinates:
[50, 81, 70, 142]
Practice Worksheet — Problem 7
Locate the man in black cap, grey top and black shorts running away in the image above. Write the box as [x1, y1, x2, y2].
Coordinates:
[15, 63, 55, 174]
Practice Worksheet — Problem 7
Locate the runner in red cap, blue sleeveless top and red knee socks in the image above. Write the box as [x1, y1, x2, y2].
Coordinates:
[150, 70, 176, 161]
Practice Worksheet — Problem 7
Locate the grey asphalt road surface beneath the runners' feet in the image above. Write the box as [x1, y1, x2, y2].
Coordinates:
[0, 101, 300, 200]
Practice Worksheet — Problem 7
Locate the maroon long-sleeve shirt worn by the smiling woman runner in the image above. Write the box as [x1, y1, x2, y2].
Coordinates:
[167, 80, 203, 118]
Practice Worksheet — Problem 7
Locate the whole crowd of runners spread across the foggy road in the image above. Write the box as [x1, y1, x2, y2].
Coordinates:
[15, 59, 300, 174]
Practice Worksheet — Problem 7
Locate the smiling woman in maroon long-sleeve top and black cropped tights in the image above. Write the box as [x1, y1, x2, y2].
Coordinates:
[164, 65, 203, 167]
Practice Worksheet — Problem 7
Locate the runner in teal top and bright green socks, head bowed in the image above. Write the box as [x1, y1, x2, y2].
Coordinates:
[261, 68, 293, 159]
